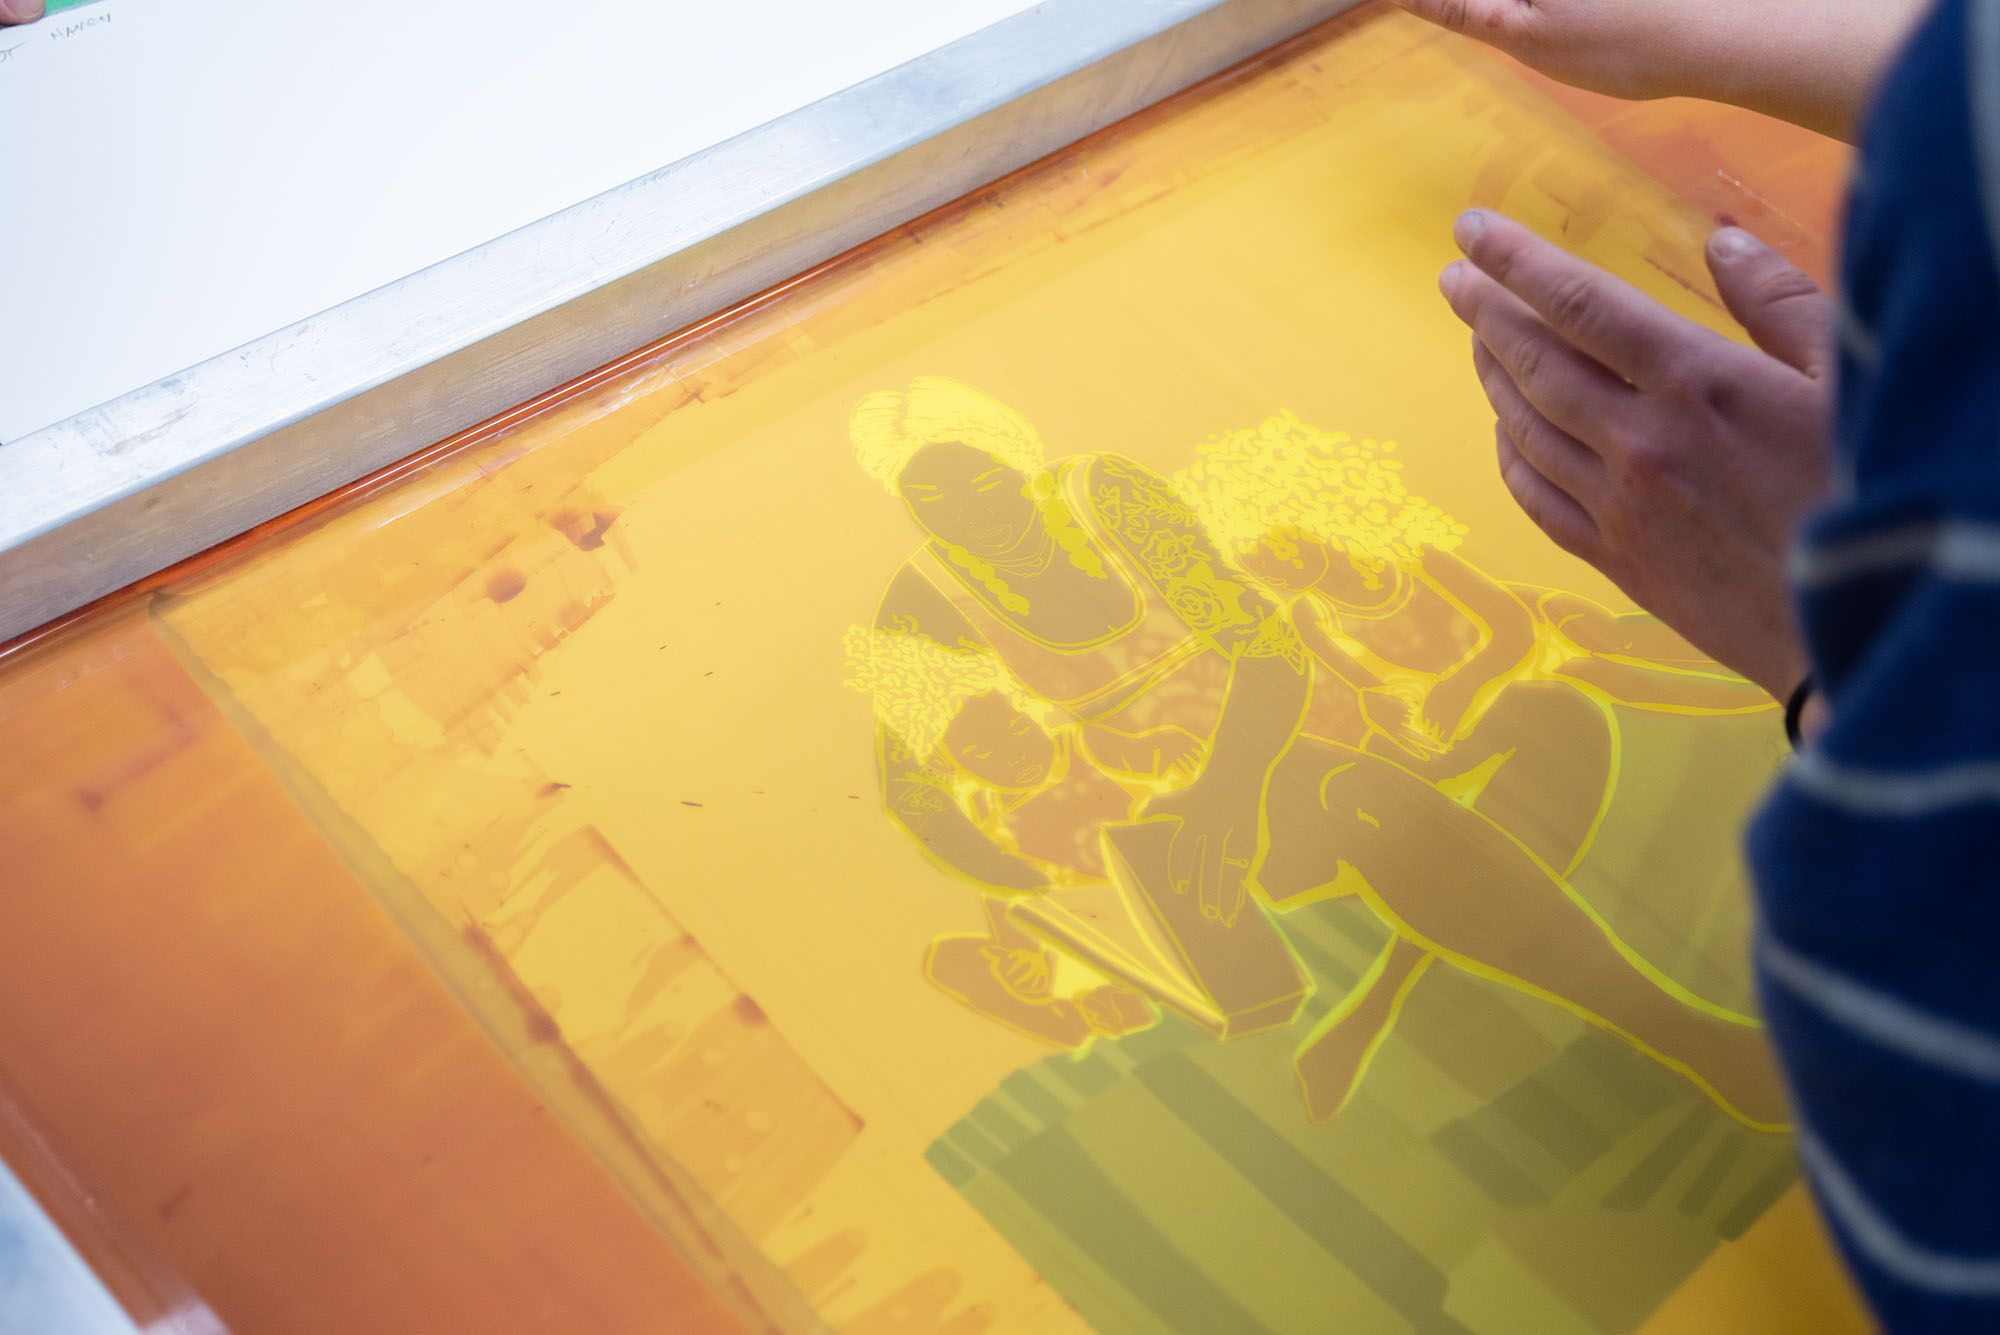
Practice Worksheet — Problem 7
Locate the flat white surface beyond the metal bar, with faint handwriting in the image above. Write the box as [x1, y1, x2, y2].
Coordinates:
[0, 0, 1032, 442]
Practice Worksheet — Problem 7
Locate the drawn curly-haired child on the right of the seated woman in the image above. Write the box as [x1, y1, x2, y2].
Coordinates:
[1176, 414, 1774, 1113]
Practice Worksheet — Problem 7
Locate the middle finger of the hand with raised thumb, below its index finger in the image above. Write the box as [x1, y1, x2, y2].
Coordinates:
[1440, 262, 1636, 446]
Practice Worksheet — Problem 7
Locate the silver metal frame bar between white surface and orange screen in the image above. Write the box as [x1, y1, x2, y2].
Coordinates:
[0, 0, 1358, 644]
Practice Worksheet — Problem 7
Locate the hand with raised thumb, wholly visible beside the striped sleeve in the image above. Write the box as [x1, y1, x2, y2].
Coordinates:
[1440, 210, 1832, 699]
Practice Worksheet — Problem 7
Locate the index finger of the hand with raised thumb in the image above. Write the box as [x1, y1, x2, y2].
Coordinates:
[1452, 208, 1706, 390]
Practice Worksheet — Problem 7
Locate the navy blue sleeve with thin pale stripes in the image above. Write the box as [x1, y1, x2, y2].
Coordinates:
[1750, 0, 2000, 1331]
